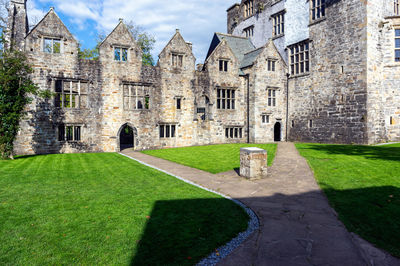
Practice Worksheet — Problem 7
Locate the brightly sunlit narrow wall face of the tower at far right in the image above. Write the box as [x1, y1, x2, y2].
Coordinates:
[367, 0, 400, 143]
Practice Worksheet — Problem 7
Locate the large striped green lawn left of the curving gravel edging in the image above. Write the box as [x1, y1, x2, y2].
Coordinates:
[0, 153, 248, 265]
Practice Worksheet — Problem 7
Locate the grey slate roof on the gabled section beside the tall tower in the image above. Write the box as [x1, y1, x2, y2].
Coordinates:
[206, 32, 256, 64]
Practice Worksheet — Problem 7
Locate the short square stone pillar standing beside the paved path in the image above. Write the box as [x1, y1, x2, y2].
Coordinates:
[240, 147, 267, 179]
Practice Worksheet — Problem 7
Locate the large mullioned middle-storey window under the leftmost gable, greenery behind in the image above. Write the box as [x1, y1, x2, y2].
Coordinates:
[51, 77, 90, 109]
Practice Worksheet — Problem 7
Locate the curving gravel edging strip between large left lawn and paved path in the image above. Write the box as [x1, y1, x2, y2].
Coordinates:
[119, 153, 260, 266]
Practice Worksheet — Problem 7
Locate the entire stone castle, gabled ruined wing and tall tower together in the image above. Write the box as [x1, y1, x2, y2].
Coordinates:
[7, 0, 400, 154]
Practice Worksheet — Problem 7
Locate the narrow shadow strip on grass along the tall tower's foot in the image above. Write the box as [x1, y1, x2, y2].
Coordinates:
[297, 143, 400, 161]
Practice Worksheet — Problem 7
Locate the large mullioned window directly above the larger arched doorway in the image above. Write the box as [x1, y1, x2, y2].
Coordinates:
[121, 81, 152, 111]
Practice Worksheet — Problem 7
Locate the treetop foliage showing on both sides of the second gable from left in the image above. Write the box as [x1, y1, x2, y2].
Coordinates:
[79, 20, 156, 66]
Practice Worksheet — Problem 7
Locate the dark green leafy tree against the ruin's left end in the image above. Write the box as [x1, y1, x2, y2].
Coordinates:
[0, 37, 51, 159]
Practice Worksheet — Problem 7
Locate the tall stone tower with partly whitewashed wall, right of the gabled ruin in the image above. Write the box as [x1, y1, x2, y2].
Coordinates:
[227, 0, 400, 144]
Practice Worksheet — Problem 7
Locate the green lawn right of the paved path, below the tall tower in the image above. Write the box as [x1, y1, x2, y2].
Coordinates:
[296, 144, 400, 257]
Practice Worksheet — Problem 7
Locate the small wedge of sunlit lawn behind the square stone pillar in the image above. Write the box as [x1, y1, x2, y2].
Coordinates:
[143, 144, 277, 174]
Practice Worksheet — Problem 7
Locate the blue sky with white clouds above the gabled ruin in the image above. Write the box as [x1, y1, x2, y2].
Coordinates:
[27, 0, 235, 63]
